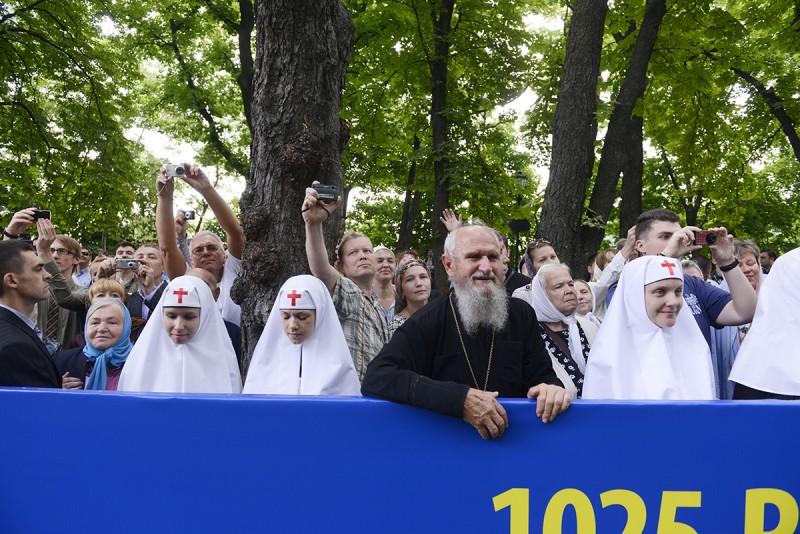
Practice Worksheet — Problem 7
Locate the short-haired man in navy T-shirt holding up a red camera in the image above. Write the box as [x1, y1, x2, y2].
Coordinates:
[606, 209, 756, 346]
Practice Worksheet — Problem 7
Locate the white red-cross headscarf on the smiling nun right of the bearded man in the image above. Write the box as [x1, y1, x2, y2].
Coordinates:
[583, 256, 715, 400]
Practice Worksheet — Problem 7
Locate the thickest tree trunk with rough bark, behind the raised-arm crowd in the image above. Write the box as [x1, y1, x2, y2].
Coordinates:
[233, 0, 354, 368]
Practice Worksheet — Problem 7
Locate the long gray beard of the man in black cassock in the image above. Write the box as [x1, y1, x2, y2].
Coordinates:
[453, 278, 508, 336]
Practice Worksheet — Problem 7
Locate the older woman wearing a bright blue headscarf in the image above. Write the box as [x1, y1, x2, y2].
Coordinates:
[54, 298, 133, 391]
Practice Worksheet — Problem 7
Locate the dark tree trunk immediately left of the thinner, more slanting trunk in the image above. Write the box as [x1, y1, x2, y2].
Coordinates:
[536, 0, 608, 271]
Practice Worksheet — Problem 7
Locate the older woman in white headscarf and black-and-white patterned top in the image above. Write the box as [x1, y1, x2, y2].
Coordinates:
[513, 264, 597, 398]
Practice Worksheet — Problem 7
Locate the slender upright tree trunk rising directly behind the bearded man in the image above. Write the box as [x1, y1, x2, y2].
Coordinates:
[428, 0, 454, 294]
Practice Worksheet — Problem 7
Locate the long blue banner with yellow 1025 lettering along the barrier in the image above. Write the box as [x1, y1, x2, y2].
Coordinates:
[0, 389, 800, 534]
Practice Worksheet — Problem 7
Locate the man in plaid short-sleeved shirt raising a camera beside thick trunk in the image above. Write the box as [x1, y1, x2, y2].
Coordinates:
[302, 182, 389, 380]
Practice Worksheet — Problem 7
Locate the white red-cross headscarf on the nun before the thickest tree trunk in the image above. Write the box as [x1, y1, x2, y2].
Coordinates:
[244, 275, 361, 395]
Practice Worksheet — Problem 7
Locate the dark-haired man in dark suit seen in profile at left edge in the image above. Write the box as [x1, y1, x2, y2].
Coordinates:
[0, 241, 61, 388]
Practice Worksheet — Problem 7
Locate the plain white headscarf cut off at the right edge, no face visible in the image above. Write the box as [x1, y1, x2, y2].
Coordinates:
[730, 248, 800, 396]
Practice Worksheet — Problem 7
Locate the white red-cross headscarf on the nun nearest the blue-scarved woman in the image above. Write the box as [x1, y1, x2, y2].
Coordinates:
[117, 276, 242, 393]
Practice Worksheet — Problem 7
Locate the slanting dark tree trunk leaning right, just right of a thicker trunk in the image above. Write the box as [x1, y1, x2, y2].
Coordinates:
[581, 0, 667, 258]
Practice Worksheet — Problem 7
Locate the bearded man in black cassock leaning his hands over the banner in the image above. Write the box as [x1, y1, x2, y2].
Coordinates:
[361, 224, 572, 439]
